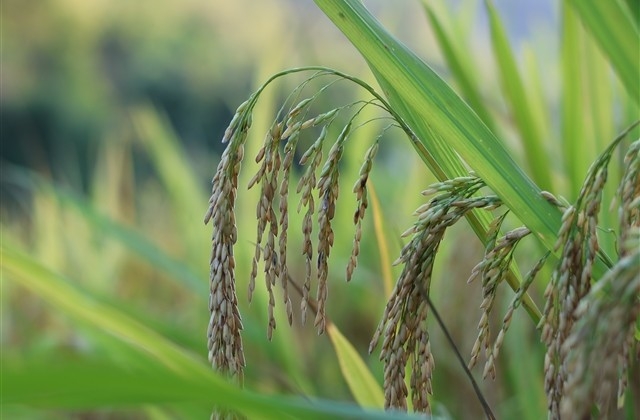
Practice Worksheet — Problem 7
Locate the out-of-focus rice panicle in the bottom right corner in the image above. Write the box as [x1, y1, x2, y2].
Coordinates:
[559, 227, 640, 418]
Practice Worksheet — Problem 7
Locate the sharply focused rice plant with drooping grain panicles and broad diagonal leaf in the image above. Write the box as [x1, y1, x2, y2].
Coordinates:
[205, 0, 640, 418]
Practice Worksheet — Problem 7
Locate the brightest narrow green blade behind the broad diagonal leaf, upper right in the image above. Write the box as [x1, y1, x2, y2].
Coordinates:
[485, 0, 553, 190]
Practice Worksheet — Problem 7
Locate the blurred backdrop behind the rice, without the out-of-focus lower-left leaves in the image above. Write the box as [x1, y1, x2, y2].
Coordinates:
[5, 0, 620, 418]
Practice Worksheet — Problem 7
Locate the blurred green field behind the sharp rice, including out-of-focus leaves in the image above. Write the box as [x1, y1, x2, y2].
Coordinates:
[0, 0, 640, 419]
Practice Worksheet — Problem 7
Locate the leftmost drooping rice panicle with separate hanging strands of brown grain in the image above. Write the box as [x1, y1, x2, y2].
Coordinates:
[205, 72, 377, 362]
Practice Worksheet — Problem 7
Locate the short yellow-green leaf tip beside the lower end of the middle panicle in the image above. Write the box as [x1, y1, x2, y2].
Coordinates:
[327, 322, 384, 408]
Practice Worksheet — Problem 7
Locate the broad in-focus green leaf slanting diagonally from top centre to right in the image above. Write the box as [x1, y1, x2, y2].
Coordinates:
[316, 0, 605, 282]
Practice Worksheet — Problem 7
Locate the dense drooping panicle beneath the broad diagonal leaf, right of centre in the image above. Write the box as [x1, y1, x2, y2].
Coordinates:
[369, 177, 501, 412]
